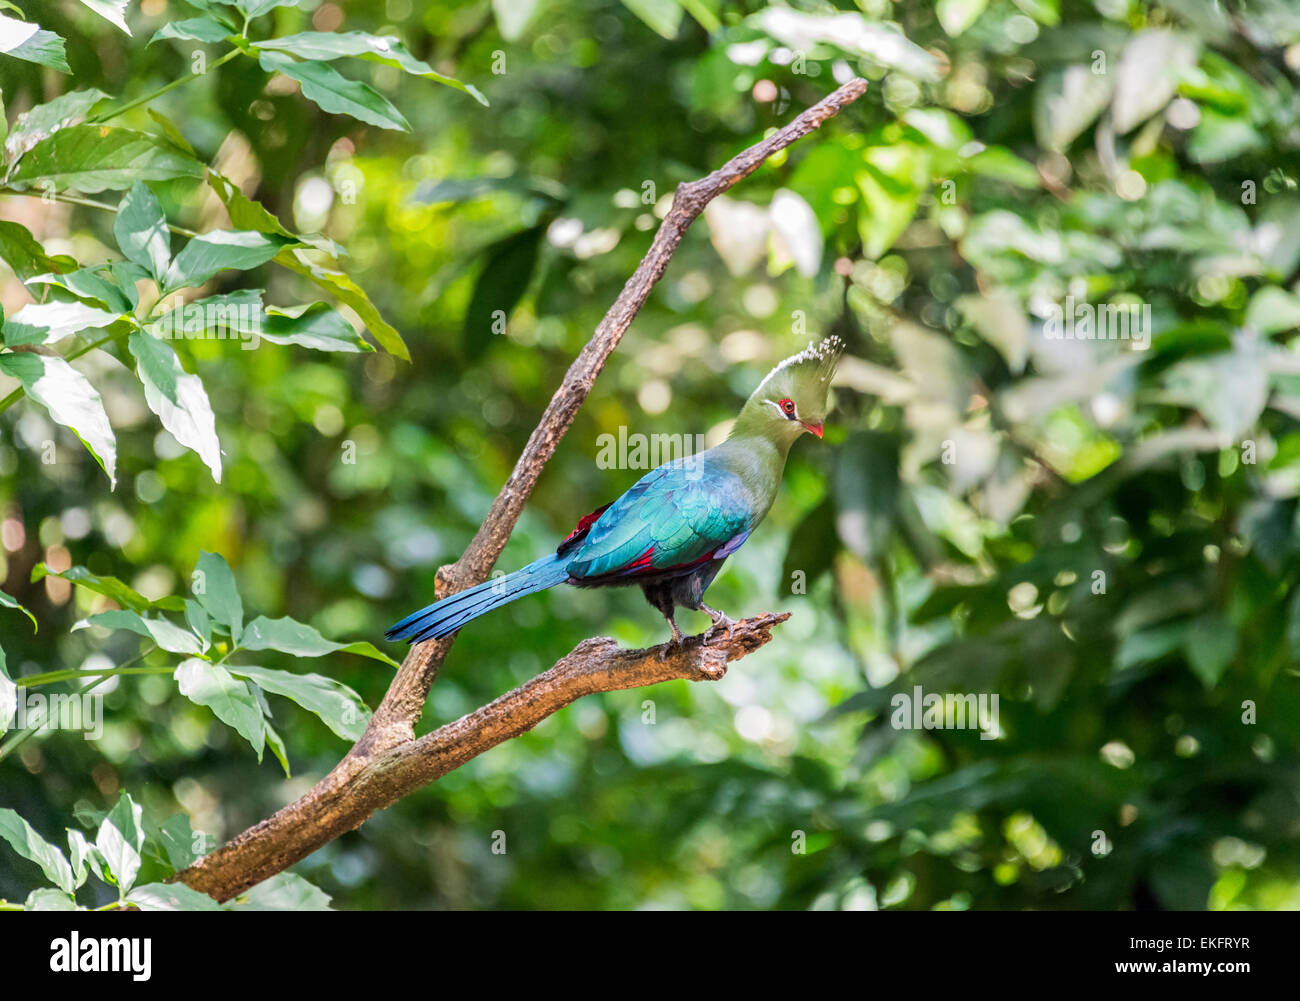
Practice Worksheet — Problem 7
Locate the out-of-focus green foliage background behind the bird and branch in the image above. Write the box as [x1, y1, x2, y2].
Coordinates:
[0, 0, 1300, 909]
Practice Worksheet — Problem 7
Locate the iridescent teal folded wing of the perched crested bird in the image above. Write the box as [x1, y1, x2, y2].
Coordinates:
[568, 462, 754, 580]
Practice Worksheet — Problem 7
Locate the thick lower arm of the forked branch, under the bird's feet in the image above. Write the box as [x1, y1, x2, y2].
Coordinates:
[171, 612, 789, 901]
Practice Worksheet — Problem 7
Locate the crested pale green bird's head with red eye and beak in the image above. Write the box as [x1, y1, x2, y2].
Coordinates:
[736, 335, 844, 447]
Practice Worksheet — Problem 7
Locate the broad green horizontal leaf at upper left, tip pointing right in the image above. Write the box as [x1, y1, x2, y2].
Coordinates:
[8, 125, 203, 195]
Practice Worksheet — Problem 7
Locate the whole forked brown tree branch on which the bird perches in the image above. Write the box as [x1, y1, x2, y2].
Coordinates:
[177, 79, 867, 900]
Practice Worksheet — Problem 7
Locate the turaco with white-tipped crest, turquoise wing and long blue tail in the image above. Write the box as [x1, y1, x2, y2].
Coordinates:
[385, 335, 844, 647]
